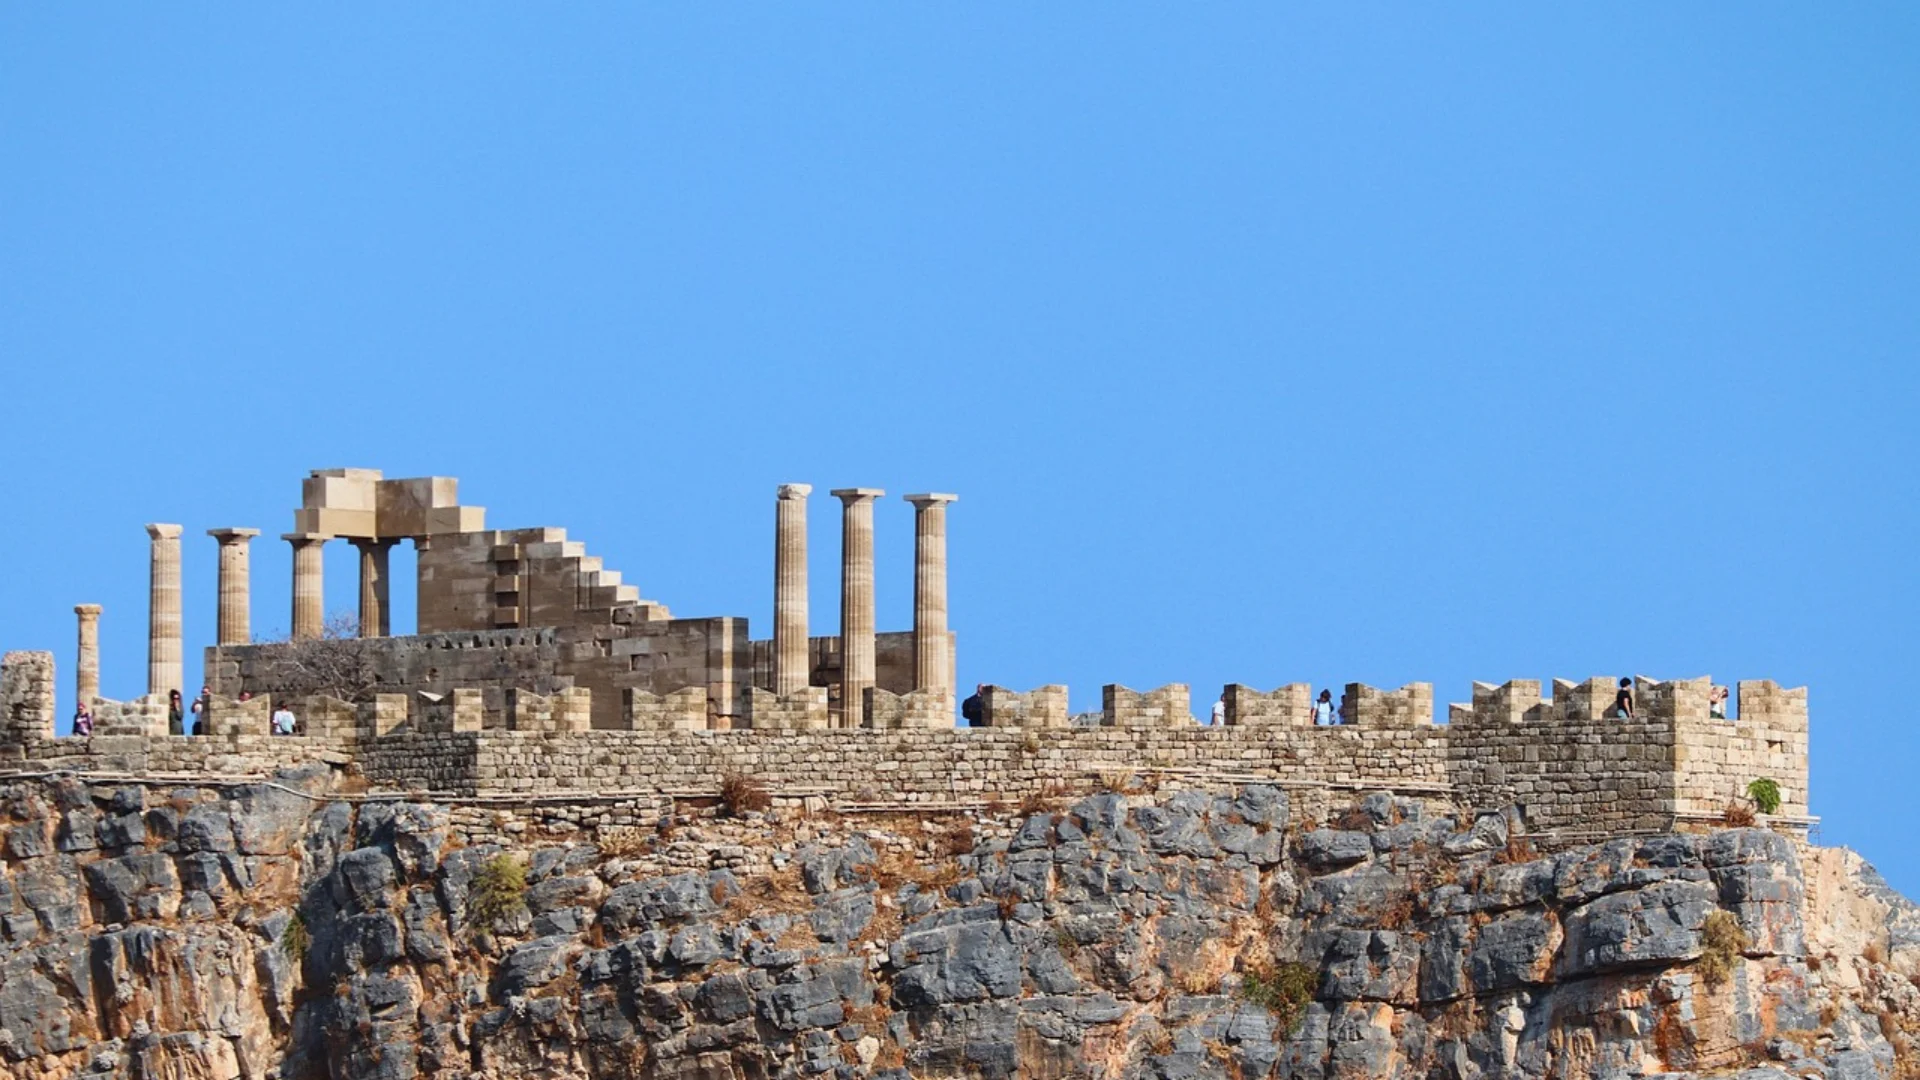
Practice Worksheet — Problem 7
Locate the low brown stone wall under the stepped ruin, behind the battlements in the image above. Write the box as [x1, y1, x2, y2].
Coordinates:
[207, 614, 749, 730]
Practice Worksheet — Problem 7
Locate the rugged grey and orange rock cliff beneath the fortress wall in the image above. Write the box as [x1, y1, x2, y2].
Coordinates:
[0, 767, 1920, 1080]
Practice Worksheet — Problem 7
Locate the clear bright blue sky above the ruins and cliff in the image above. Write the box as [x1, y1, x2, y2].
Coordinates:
[0, 12, 1920, 894]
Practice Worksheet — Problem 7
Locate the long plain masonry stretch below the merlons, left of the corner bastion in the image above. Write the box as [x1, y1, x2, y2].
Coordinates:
[345, 726, 1448, 805]
